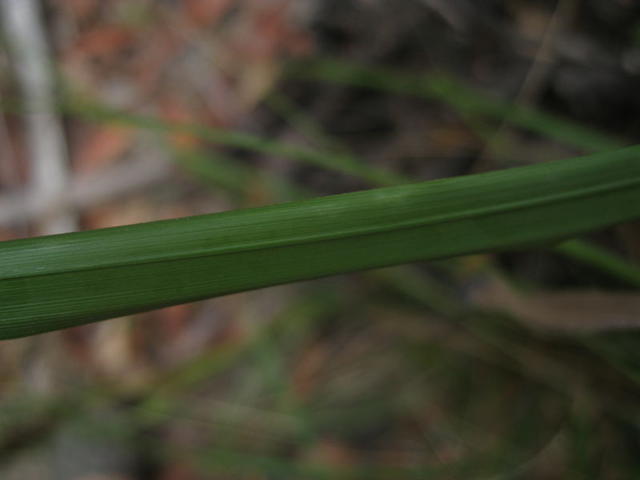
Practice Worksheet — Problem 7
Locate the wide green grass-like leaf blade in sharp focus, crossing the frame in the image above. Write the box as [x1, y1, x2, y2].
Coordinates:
[0, 147, 640, 339]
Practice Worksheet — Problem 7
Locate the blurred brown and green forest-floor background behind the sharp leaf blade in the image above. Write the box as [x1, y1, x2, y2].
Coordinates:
[0, 0, 640, 480]
